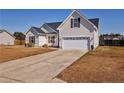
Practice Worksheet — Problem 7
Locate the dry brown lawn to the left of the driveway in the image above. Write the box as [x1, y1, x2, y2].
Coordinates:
[0, 46, 55, 63]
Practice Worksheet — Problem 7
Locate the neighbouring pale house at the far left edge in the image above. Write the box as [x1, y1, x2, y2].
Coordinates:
[0, 29, 15, 45]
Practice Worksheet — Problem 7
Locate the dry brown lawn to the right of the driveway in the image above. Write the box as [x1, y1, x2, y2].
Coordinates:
[57, 46, 124, 83]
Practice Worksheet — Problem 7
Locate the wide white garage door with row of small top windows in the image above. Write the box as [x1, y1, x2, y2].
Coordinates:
[62, 37, 89, 50]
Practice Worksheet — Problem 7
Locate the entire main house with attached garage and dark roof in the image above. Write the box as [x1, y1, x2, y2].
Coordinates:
[26, 10, 99, 50]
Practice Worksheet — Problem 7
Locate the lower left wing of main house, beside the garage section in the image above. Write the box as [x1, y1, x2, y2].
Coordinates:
[26, 22, 62, 47]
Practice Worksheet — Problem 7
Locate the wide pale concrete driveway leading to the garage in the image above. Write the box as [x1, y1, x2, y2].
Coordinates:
[0, 50, 86, 83]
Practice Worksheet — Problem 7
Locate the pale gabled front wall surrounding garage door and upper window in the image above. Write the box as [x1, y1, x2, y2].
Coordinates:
[59, 13, 93, 47]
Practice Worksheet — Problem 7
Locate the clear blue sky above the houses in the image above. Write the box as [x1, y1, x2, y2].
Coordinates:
[0, 9, 124, 34]
